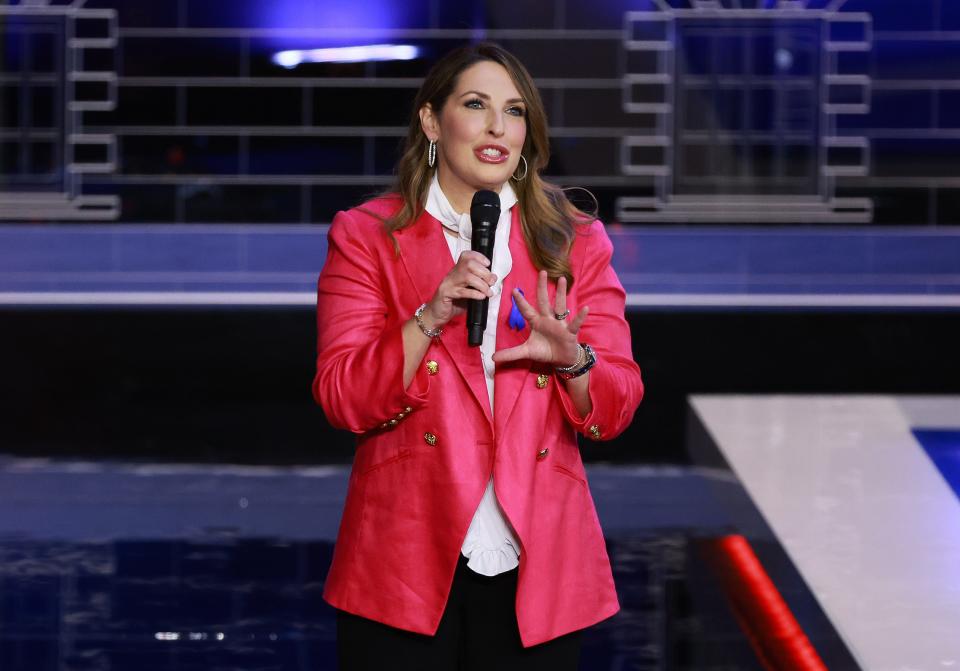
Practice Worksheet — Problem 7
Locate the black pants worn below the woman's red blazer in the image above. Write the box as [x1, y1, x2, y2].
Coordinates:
[337, 557, 581, 671]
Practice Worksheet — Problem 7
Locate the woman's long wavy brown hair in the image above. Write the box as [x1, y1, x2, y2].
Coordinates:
[384, 42, 593, 285]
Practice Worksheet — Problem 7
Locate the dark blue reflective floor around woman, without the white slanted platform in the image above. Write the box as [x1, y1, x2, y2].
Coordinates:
[0, 459, 856, 671]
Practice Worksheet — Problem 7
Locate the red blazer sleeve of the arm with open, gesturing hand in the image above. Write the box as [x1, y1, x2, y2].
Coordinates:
[554, 221, 643, 440]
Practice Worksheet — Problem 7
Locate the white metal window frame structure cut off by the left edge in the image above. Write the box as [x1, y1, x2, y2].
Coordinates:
[0, 0, 120, 221]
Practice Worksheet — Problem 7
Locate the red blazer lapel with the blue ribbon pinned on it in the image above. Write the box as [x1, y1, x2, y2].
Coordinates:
[493, 206, 537, 436]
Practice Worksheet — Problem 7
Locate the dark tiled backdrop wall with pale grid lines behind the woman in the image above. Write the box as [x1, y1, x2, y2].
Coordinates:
[0, 0, 960, 223]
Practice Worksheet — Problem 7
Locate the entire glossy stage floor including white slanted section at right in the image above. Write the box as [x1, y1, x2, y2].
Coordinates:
[0, 396, 960, 671]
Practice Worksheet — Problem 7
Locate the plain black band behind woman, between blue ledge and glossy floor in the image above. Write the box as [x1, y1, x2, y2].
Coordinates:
[0, 309, 960, 464]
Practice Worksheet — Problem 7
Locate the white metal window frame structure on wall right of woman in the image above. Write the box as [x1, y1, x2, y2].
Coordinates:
[616, 0, 873, 224]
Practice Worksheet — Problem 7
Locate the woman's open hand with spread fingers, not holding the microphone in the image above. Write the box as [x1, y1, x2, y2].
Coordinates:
[493, 270, 590, 367]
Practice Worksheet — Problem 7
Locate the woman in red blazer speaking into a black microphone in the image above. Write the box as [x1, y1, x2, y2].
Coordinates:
[313, 44, 643, 671]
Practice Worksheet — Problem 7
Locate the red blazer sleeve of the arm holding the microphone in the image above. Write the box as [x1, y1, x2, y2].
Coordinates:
[313, 212, 429, 433]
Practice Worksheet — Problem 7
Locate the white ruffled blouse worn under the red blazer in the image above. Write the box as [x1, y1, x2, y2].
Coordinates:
[426, 175, 520, 576]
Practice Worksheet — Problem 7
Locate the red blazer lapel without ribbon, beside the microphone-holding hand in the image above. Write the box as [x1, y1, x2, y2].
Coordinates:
[395, 212, 496, 422]
